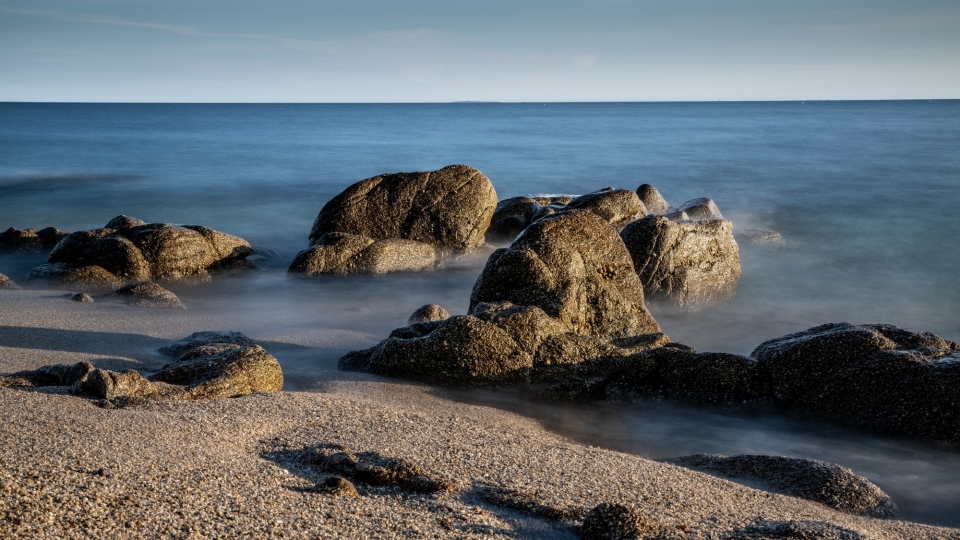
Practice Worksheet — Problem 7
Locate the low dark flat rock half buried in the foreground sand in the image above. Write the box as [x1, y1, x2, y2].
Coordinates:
[300, 444, 457, 493]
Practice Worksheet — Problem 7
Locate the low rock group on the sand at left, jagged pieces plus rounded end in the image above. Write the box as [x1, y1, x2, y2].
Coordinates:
[0, 332, 283, 407]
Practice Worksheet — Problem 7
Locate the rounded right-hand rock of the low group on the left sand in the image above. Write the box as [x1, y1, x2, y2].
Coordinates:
[150, 345, 283, 399]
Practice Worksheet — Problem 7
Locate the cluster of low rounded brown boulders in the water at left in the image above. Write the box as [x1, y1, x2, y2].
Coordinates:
[27, 216, 255, 290]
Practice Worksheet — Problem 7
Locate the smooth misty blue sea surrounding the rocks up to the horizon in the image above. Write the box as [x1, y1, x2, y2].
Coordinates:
[0, 101, 960, 526]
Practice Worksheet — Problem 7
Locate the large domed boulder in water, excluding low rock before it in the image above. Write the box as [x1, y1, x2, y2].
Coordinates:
[310, 165, 497, 252]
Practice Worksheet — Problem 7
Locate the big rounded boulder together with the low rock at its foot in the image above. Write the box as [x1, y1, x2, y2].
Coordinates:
[289, 165, 497, 276]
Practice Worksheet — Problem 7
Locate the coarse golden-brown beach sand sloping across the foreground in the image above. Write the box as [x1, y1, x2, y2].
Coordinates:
[0, 290, 960, 539]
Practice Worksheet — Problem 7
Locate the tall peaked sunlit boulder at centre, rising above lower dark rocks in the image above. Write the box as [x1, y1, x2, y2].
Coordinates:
[470, 210, 660, 338]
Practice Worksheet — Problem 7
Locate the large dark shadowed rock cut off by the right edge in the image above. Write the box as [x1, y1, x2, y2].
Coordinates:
[751, 323, 960, 443]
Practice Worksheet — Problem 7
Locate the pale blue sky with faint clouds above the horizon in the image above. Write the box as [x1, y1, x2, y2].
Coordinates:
[0, 0, 960, 102]
